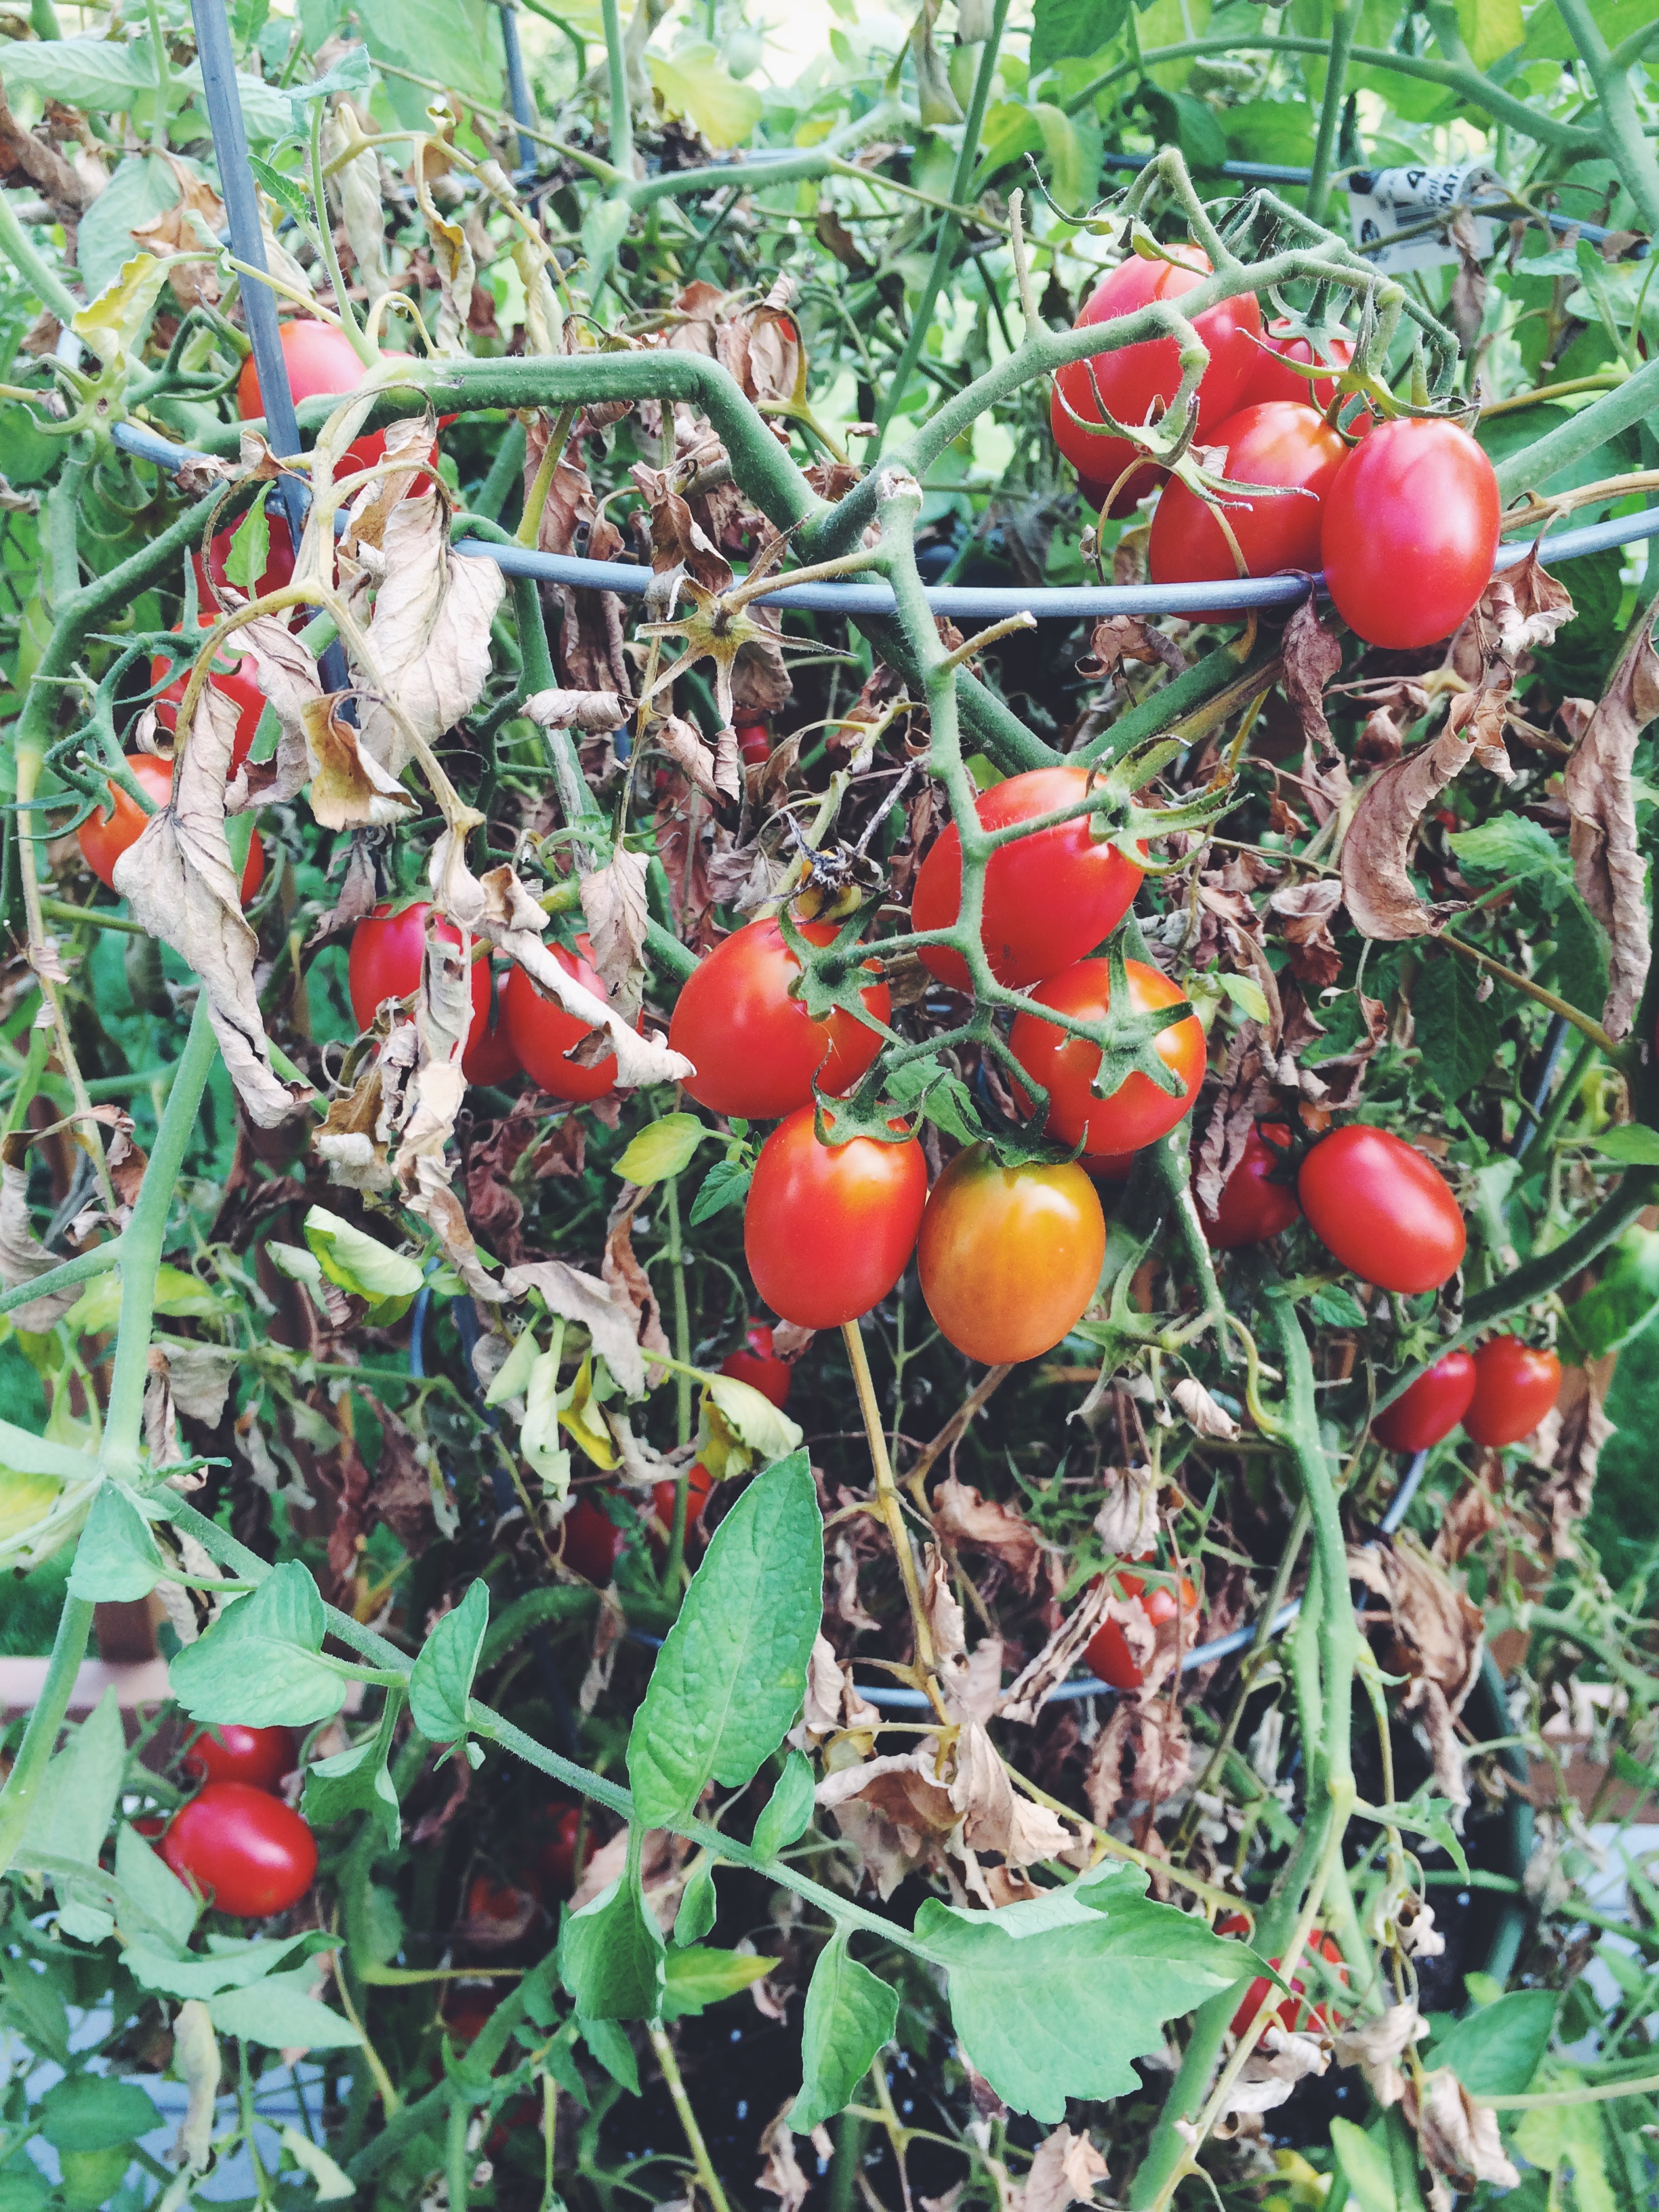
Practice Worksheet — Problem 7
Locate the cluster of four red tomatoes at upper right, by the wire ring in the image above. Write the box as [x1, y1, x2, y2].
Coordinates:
[1050, 248, 1502, 648]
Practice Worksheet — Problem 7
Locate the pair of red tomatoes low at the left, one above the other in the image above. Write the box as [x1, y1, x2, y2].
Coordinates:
[161, 1723, 316, 1920]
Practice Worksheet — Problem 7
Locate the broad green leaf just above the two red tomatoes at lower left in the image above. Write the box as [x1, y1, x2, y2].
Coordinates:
[168, 1559, 345, 1727]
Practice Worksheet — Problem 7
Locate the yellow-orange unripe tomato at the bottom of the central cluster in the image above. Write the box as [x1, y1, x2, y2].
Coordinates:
[916, 1143, 1106, 1367]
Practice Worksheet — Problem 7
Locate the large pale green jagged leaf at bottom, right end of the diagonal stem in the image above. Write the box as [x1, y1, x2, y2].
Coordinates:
[916, 1862, 1263, 2126]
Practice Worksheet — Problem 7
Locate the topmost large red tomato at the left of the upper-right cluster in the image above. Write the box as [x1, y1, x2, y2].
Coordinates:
[1048, 245, 1261, 516]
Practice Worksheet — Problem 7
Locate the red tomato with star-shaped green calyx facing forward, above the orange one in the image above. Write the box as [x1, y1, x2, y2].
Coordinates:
[1008, 960, 1206, 1153]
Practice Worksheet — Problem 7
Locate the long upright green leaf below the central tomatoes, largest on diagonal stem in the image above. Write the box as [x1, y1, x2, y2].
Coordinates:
[628, 1451, 823, 1822]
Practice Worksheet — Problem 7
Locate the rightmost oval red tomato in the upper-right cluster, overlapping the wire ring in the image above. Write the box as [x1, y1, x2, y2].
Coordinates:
[1321, 416, 1502, 646]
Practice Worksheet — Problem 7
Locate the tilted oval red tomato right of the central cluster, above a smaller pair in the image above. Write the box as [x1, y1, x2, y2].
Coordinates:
[1296, 1122, 1469, 1292]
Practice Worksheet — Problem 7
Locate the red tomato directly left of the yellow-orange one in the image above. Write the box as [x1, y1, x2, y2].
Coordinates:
[743, 1106, 927, 1330]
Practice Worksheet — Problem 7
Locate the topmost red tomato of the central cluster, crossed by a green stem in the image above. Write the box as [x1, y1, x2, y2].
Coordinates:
[909, 768, 1141, 991]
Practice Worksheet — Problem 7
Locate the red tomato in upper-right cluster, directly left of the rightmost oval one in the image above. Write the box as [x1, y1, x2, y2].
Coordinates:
[1146, 401, 1347, 601]
